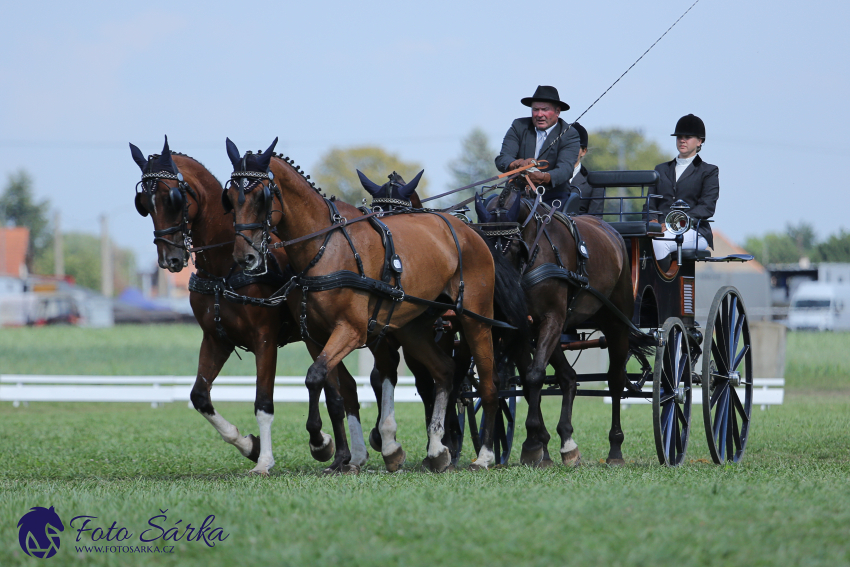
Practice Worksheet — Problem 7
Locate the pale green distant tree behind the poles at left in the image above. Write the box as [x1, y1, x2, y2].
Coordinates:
[35, 232, 139, 295]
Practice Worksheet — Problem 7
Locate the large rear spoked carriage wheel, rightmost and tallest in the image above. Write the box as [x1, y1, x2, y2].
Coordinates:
[702, 286, 753, 465]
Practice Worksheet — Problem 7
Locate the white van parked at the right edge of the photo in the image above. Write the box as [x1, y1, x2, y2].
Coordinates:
[788, 282, 850, 331]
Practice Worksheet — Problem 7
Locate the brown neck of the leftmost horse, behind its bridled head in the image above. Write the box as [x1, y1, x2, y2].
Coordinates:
[173, 156, 234, 276]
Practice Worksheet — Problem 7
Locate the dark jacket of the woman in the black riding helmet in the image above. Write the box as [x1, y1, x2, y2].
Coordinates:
[650, 156, 720, 248]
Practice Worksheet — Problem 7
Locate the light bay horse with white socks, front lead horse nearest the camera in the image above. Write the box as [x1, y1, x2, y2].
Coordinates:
[225, 139, 520, 472]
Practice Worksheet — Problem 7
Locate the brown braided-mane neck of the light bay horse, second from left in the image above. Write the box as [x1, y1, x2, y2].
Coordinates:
[269, 157, 338, 265]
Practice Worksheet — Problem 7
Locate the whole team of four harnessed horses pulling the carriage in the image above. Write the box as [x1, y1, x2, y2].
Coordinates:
[130, 131, 652, 474]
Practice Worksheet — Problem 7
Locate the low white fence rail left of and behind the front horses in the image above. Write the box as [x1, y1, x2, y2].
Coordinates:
[0, 374, 419, 407]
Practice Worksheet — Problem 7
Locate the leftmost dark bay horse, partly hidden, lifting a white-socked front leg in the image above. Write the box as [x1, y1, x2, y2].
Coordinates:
[130, 137, 368, 475]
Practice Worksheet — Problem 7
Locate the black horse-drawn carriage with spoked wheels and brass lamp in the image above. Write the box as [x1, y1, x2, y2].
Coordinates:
[453, 171, 753, 466]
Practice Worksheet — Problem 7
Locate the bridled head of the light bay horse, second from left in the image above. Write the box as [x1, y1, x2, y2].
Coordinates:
[221, 138, 283, 275]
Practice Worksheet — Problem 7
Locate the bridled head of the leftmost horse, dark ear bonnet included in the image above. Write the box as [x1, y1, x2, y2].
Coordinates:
[130, 136, 198, 272]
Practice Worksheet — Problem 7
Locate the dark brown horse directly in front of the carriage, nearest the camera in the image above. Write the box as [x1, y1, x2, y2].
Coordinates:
[476, 183, 654, 467]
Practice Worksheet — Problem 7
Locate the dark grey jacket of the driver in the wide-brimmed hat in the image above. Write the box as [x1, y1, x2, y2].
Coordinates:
[496, 117, 580, 201]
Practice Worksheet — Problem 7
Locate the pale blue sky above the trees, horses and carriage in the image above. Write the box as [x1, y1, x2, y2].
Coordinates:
[0, 0, 850, 269]
